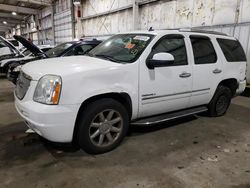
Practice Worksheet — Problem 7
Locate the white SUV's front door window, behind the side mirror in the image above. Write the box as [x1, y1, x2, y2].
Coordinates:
[149, 35, 188, 66]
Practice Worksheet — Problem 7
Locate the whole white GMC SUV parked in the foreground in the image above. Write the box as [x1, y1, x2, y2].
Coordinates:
[15, 30, 246, 154]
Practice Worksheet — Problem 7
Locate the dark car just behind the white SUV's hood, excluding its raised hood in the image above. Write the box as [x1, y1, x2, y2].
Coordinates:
[7, 39, 102, 84]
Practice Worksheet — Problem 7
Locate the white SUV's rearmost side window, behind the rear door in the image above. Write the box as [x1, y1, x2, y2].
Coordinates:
[217, 39, 246, 62]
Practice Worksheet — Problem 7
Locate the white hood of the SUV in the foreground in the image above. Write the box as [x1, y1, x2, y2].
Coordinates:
[22, 56, 121, 80]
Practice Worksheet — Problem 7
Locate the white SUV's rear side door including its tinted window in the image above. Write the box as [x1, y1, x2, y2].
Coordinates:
[190, 35, 222, 106]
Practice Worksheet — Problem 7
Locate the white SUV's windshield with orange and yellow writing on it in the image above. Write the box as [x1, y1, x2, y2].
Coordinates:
[88, 34, 154, 63]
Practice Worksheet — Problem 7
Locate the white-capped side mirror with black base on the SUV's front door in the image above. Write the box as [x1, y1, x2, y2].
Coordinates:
[146, 52, 174, 69]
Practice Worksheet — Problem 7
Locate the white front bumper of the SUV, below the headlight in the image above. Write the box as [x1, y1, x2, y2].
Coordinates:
[15, 96, 79, 143]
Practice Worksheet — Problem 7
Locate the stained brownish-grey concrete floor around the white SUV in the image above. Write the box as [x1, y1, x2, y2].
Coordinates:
[0, 79, 250, 188]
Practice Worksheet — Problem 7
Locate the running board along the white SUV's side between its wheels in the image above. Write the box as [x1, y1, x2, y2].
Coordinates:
[131, 106, 208, 126]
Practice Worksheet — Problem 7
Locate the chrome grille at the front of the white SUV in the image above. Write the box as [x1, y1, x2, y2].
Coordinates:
[15, 71, 31, 100]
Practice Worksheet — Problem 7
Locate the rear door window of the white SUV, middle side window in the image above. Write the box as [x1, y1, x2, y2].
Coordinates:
[190, 36, 217, 65]
